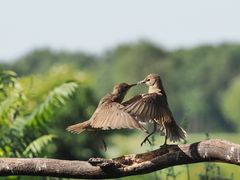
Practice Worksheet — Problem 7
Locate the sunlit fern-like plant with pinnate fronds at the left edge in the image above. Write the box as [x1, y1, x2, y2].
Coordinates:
[0, 71, 77, 157]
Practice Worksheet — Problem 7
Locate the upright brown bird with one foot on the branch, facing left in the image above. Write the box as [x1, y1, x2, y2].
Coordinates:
[123, 74, 187, 145]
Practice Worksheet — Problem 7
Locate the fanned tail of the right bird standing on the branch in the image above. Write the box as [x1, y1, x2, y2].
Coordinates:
[164, 121, 187, 142]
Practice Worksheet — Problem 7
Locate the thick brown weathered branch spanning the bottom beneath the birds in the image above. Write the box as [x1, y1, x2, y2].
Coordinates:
[0, 139, 240, 179]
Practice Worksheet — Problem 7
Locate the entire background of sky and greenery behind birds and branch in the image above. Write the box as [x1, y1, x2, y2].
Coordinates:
[0, 0, 240, 179]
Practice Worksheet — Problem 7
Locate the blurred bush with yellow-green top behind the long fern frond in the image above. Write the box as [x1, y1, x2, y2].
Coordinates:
[16, 64, 101, 159]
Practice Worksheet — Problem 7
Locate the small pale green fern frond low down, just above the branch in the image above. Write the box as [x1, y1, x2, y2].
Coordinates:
[23, 134, 56, 157]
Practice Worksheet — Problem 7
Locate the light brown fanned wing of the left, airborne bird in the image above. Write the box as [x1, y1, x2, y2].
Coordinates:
[90, 102, 144, 130]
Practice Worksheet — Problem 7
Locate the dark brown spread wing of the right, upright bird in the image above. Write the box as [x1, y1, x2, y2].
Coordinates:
[123, 93, 173, 123]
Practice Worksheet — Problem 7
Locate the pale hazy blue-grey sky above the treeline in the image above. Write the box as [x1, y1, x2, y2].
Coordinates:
[0, 0, 240, 61]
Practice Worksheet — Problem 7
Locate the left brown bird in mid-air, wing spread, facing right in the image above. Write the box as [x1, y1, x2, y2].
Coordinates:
[67, 83, 144, 149]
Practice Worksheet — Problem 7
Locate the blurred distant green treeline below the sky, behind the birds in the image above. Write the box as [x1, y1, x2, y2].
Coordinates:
[2, 41, 240, 132]
